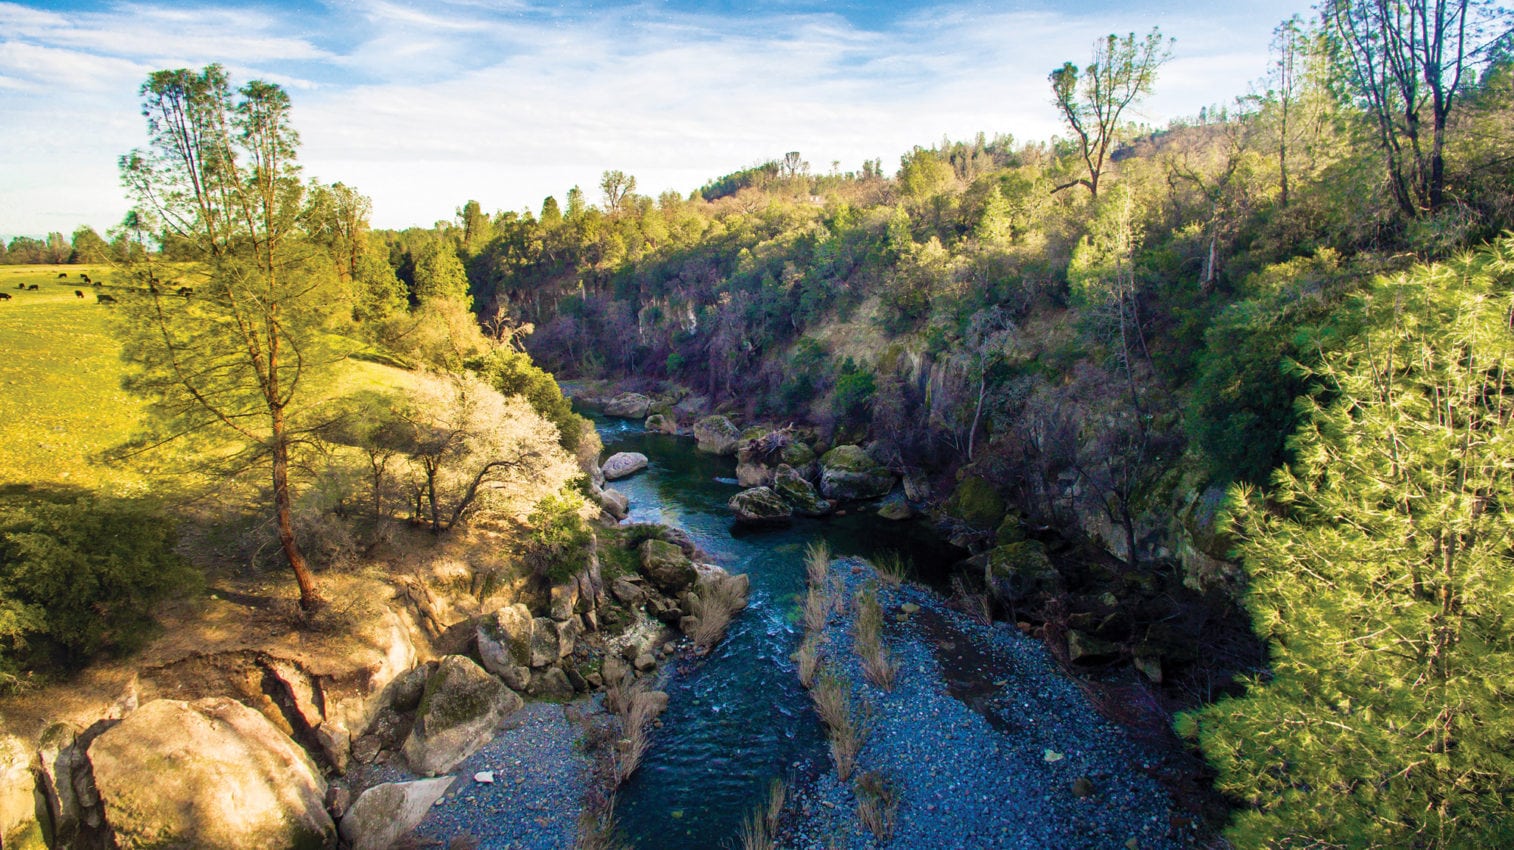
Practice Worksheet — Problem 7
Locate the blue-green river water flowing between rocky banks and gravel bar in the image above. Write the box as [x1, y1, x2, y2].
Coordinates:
[597, 420, 952, 850]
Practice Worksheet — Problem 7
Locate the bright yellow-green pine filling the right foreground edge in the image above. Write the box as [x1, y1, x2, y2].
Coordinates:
[1182, 239, 1514, 847]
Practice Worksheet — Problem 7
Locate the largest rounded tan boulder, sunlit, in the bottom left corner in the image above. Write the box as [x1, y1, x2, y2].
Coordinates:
[89, 697, 336, 850]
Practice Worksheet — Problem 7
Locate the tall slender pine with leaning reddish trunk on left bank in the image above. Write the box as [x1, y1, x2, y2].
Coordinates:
[121, 65, 341, 611]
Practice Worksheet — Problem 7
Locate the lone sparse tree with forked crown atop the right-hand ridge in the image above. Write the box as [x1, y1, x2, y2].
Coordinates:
[1048, 27, 1172, 197]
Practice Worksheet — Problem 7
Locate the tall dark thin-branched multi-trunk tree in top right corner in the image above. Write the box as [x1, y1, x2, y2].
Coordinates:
[1323, 0, 1514, 217]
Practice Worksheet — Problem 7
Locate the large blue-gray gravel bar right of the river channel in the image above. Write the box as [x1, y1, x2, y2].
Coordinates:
[786, 561, 1198, 850]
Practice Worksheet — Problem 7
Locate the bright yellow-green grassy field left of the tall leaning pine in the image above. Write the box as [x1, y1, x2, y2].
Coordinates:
[0, 265, 142, 489]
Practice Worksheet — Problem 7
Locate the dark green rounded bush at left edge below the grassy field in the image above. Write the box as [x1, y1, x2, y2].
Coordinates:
[0, 488, 200, 685]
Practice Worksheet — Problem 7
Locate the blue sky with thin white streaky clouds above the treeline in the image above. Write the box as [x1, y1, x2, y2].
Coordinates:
[0, 0, 1311, 239]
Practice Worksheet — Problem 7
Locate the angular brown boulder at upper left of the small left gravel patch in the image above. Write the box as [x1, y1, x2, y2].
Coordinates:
[404, 655, 524, 776]
